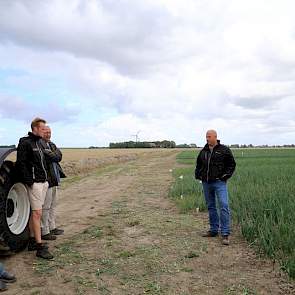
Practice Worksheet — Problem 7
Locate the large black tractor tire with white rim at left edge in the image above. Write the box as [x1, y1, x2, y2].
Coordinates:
[0, 161, 30, 252]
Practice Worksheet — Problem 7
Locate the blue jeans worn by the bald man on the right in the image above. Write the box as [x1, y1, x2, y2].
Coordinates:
[203, 180, 230, 236]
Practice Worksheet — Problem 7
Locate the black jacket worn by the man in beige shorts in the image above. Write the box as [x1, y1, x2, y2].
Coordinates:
[16, 132, 48, 185]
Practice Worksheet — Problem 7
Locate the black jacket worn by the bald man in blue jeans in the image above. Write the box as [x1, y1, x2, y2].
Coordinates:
[195, 141, 236, 182]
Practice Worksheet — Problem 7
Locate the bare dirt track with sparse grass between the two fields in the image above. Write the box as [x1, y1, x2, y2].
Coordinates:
[5, 151, 295, 295]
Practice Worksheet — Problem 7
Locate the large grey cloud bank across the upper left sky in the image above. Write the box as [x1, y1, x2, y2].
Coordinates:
[0, 0, 178, 73]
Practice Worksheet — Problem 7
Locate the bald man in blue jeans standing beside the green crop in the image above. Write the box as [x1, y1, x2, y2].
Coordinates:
[195, 130, 236, 245]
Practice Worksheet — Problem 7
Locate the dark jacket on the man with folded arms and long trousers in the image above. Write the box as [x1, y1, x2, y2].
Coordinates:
[43, 141, 65, 187]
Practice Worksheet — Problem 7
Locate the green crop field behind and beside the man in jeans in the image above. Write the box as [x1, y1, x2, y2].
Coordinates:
[170, 149, 295, 278]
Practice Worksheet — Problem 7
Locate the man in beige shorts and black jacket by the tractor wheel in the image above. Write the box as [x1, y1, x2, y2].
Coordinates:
[16, 118, 53, 259]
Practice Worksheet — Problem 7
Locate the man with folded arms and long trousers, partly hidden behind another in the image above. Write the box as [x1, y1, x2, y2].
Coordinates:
[41, 126, 65, 240]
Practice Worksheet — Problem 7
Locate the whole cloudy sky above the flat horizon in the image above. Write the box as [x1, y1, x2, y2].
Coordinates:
[0, 0, 295, 147]
